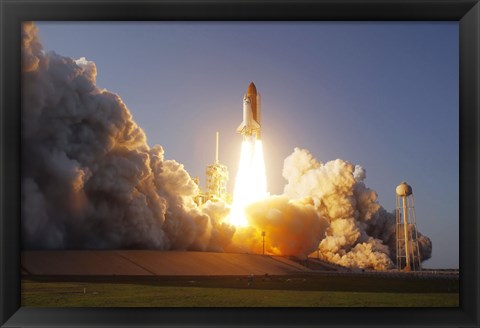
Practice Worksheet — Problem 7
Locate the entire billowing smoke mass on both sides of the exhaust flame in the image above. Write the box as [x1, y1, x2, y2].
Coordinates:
[22, 23, 431, 269]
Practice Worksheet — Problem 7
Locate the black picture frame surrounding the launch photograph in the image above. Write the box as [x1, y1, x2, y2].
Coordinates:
[0, 0, 480, 327]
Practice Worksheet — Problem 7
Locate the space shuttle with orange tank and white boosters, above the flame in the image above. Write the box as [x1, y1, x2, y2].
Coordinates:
[237, 82, 261, 139]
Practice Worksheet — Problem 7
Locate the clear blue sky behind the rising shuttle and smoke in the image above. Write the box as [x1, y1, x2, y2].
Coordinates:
[37, 22, 459, 268]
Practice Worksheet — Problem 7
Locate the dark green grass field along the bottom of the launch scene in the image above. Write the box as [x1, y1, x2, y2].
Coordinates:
[22, 276, 459, 307]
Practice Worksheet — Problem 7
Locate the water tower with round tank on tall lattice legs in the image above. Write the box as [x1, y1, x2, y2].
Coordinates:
[395, 181, 422, 271]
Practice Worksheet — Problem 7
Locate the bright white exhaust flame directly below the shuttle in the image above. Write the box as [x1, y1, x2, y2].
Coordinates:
[229, 140, 268, 227]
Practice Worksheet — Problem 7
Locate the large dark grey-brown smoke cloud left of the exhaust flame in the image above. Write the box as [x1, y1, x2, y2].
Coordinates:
[22, 23, 234, 251]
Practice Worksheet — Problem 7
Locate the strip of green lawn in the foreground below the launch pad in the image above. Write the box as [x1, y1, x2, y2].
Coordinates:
[22, 280, 459, 307]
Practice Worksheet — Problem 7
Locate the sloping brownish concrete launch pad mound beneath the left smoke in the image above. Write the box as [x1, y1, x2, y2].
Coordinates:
[22, 250, 311, 276]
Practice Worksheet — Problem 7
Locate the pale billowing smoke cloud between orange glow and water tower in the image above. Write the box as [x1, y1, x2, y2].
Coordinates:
[283, 148, 432, 270]
